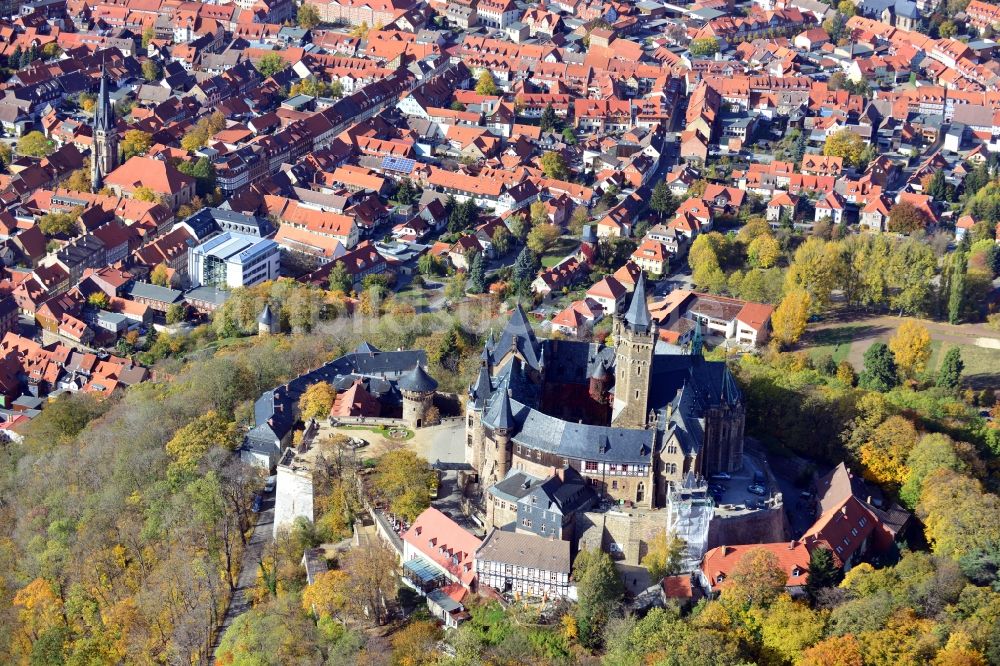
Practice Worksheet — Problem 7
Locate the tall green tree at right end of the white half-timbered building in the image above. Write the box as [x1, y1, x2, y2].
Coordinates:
[573, 550, 624, 647]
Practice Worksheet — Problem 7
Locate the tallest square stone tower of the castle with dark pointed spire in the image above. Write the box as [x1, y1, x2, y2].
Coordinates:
[611, 274, 656, 428]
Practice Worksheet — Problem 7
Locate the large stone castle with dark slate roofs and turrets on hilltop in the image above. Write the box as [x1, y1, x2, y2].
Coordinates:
[466, 277, 745, 508]
